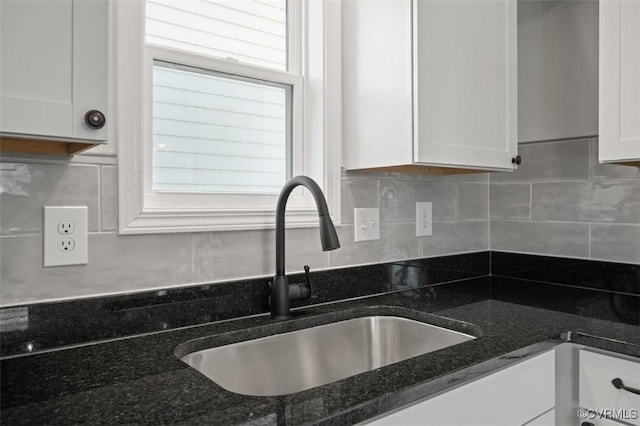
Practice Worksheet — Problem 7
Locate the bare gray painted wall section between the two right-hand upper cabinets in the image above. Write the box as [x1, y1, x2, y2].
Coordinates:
[518, 0, 608, 142]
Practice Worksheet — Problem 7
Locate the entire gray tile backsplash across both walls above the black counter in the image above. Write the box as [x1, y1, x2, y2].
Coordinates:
[0, 135, 640, 306]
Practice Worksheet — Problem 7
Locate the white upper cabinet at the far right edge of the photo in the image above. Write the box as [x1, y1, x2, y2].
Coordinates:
[599, 0, 640, 162]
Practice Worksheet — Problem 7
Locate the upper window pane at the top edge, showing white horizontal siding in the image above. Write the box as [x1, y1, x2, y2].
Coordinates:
[146, 0, 287, 71]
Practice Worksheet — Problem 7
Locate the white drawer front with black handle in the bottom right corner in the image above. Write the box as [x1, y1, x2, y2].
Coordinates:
[579, 351, 640, 425]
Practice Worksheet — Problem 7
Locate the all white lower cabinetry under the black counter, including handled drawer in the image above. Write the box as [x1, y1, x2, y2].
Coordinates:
[363, 343, 640, 426]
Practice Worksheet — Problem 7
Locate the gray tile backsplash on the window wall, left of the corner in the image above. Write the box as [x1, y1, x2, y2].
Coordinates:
[0, 156, 489, 306]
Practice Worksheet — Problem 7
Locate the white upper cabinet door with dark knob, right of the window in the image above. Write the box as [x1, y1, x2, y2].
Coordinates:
[413, 0, 526, 170]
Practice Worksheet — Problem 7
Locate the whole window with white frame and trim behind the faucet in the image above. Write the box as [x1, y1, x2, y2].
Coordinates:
[114, 0, 341, 233]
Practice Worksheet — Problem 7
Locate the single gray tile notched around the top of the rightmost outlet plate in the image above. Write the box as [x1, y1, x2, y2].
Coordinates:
[380, 179, 458, 223]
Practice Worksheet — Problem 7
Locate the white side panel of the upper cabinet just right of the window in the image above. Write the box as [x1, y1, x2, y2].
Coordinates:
[342, 0, 413, 169]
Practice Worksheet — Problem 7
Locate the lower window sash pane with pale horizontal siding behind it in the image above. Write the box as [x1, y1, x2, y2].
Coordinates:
[153, 62, 291, 193]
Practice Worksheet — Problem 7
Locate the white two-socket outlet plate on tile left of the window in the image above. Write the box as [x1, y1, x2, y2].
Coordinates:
[43, 206, 89, 266]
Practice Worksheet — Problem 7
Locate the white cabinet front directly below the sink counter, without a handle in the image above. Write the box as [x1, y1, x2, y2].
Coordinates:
[367, 350, 555, 426]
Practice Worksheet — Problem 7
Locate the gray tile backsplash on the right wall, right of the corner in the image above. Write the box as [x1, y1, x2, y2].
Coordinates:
[490, 139, 640, 264]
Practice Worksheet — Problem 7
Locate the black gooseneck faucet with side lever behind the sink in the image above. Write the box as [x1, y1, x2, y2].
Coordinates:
[271, 176, 340, 320]
